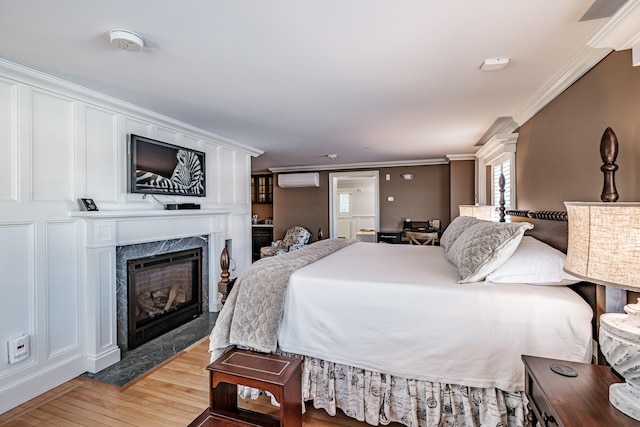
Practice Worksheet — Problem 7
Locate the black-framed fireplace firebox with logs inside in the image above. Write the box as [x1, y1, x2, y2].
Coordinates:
[127, 248, 202, 350]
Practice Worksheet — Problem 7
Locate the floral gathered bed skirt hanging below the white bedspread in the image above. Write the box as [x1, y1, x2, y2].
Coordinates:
[283, 353, 528, 427]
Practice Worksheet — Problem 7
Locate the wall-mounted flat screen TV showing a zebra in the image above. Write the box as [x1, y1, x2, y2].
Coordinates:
[129, 135, 206, 197]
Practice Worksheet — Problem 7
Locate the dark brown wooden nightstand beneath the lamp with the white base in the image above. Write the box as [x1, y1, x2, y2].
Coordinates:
[522, 356, 640, 427]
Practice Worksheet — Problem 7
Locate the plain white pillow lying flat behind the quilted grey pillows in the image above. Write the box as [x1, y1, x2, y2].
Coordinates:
[485, 236, 580, 286]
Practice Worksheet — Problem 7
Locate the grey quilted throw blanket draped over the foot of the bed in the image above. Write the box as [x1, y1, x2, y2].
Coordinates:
[209, 239, 355, 360]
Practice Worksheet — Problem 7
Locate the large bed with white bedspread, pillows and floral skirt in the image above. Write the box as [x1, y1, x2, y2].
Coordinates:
[210, 212, 593, 427]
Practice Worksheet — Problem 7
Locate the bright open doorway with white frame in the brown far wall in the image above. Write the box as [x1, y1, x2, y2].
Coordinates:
[329, 170, 380, 241]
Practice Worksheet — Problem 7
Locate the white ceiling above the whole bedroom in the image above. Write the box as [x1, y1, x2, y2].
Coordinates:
[0, 0, 624, 171]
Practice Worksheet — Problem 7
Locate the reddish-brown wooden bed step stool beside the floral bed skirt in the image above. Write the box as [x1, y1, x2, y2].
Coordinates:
[189, 348, 302, 427]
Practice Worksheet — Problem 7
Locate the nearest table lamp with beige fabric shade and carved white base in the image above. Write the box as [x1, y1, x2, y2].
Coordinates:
[564, 201, 640, 421]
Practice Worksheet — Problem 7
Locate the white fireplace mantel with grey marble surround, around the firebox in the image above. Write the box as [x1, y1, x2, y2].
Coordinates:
[70, 209, 225, 373]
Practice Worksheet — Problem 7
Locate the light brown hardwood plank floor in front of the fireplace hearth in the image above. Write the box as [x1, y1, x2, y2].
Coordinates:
[0, 338, 399, 427]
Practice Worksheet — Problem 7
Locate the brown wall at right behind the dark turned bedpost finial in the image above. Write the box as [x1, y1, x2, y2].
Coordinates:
[516, 51, 640, 210]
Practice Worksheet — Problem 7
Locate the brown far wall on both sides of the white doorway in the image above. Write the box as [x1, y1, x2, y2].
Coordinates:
[273, 165, 456, 241]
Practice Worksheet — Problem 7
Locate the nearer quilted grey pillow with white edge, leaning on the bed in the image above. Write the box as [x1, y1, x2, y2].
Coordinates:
[445, 221, 533, 283]
